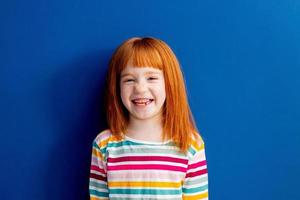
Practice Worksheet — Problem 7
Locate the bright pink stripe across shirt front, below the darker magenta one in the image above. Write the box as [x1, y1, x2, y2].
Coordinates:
[107, 164, 186, 172]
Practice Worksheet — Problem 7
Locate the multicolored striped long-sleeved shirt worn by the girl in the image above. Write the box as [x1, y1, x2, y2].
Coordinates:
[89, 130, 208, 200]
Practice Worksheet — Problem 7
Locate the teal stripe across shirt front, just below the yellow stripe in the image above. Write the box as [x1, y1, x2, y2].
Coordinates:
[109, 188, 181, 195]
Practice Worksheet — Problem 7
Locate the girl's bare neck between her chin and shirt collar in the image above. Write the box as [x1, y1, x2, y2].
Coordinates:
[126, 117, 163, 142]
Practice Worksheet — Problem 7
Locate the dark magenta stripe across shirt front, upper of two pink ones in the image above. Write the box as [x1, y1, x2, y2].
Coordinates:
[108, 156, 188, 164]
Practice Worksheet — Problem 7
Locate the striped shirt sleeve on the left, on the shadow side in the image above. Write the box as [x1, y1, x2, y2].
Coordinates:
[89, 141, 109, 200]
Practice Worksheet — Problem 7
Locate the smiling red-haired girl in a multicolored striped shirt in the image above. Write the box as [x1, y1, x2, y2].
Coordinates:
[89, 37, 208, 200]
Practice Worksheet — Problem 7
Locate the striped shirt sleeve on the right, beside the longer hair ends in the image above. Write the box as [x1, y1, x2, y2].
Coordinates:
[182, 140, 208, 200]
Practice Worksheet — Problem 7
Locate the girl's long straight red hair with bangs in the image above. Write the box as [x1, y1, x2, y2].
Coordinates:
[106, 37, 198, 152]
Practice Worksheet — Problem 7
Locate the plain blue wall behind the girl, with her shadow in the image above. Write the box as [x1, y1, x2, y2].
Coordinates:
[0, 0, 300, 200]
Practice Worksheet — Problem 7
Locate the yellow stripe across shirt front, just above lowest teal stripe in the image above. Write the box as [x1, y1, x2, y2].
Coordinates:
[108, 182, 181, 188]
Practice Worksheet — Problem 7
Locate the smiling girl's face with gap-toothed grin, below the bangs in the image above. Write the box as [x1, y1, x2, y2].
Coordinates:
[120, 64, 166, 120]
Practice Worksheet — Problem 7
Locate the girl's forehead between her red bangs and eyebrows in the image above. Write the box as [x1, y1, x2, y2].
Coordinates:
[121, 65, 163, 77]
